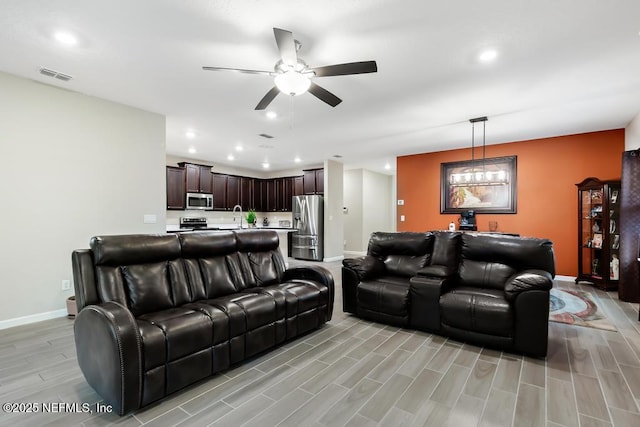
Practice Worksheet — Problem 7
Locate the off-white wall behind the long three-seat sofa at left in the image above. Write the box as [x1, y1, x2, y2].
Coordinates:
[0, 73, 166, 328]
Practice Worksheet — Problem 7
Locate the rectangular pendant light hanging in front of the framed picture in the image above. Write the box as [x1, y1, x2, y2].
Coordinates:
[449, 116, 509, 186]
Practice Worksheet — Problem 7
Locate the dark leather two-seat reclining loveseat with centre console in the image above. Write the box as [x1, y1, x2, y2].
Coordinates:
[342, 232, 555, 357]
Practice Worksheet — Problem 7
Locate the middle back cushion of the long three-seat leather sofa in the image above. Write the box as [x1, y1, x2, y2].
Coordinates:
[180, 231, 242, 301]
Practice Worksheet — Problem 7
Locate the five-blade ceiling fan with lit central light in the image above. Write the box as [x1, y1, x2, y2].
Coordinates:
[202, 28, 378, 110]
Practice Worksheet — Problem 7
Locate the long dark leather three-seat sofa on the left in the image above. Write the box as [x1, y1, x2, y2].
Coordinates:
[72, 230, 334, 415]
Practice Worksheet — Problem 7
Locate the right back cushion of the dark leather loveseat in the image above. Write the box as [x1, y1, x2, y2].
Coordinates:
[459, 233, 555, 289]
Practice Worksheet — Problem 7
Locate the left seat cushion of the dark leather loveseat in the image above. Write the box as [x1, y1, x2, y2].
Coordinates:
[356, 276, 409, 318]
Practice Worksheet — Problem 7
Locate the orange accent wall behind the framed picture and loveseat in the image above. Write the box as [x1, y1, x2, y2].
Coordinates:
[397, 129, 624, 276]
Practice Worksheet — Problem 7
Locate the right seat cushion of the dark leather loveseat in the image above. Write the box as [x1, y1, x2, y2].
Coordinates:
[440, 287, 514, 337]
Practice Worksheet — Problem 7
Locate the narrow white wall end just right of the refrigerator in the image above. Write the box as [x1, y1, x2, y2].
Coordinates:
[324, 160, 344, 261]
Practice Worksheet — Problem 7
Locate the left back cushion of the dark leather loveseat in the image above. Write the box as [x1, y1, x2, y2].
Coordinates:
[367, 231, 433, 277]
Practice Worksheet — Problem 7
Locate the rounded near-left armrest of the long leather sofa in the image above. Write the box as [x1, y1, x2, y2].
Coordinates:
[73, 302, 143, 415]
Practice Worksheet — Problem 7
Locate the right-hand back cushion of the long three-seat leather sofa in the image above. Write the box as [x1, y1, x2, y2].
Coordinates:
[235, 230, 286, 288]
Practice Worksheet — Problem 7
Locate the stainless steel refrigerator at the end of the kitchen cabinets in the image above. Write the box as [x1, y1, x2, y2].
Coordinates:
[291, 195, 324, 261]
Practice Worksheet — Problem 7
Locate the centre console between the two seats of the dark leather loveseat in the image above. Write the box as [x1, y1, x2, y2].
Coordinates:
[409, 276, 450, 332]
